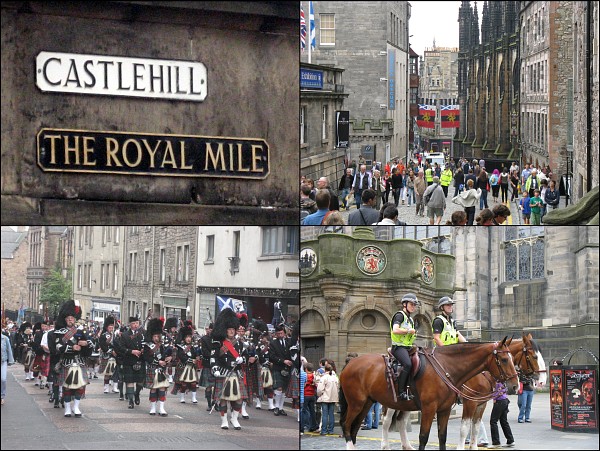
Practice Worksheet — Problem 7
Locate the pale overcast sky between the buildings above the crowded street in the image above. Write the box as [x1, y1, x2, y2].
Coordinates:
[408, 1, 483, 56]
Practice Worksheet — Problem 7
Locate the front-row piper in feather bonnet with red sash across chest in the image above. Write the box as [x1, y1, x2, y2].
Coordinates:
[210, 308, 247, 429]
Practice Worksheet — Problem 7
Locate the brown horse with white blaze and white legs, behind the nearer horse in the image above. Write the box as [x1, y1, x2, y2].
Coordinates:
[381, 334, 546, 449]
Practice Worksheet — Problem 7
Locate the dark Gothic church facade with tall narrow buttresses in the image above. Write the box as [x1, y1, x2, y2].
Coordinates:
[454, 1, 520, 160]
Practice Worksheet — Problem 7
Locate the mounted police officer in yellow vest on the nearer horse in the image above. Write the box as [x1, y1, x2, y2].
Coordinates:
[390, 293, 420, 401]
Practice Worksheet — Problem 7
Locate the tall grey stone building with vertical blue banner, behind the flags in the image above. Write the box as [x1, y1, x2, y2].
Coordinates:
[301, 1, 410, 164]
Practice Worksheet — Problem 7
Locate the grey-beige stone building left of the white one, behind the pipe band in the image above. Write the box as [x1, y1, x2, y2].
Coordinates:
[122, 226, 198, 321]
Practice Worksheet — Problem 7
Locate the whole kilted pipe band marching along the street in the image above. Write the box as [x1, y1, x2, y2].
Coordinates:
[2, 300, 300, 429]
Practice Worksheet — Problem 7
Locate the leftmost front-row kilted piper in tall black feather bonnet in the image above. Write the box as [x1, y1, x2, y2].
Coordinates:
[48, 300, 93, 418]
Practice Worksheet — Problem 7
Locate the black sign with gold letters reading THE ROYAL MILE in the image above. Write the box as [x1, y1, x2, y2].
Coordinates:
[37, 128, 269, 179]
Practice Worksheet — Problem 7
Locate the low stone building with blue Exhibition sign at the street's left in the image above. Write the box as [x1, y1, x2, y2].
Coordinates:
[300, 63, 348, 189]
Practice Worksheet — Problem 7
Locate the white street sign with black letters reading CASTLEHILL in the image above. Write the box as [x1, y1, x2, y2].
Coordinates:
[36, 52, 208, 102]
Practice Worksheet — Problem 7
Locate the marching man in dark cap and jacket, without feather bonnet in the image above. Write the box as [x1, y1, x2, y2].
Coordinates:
[115, 316, 146, 409]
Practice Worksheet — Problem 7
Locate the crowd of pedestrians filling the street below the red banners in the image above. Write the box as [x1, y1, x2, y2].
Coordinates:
[300, 158, 560, 225]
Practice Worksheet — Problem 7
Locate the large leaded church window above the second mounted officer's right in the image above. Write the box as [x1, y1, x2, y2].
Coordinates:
[504, 226, 545, 282]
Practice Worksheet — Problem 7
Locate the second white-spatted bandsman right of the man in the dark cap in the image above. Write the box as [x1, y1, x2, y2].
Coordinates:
[171, 325, 201, 404]
